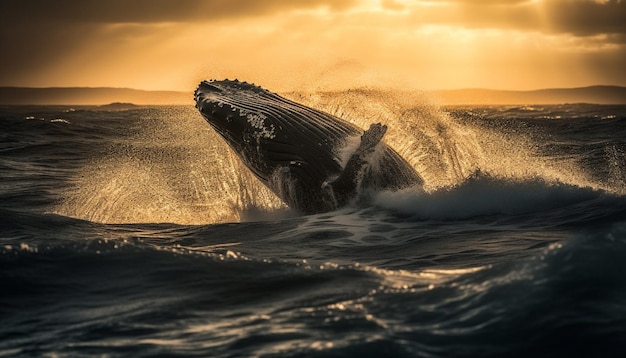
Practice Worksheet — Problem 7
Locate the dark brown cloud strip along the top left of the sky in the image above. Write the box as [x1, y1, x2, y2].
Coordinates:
[0, 0, 356, 23]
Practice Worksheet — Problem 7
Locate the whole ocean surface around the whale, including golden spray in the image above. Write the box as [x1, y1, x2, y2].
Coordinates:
[0, 90, 626, 357]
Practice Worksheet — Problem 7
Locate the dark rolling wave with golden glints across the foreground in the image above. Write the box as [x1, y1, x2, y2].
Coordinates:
[0, 215, 626, 357]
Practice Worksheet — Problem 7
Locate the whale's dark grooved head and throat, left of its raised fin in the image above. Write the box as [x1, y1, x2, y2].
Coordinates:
[195, 80, 358, 200]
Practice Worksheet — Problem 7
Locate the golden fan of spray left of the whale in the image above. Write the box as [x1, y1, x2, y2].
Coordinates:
[55, 107, 289, 224]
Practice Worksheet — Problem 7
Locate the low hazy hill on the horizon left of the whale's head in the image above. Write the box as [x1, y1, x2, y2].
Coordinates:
[0, 87, 193, 105]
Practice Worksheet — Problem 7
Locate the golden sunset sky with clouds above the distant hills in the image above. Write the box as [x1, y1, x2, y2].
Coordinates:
[0, 0, 626, 91]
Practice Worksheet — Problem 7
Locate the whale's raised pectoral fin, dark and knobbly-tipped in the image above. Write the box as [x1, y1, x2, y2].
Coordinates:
[328, 123, 387, 206]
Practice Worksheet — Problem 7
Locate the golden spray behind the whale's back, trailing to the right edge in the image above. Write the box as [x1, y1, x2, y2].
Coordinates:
[291, 89, 608, 192]
